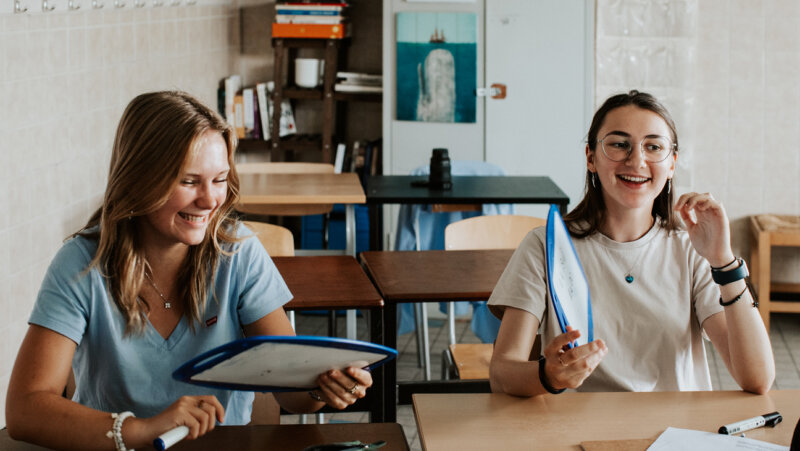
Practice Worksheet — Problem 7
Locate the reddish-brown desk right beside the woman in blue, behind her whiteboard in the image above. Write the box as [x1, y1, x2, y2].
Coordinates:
[272, 255, 387, 422]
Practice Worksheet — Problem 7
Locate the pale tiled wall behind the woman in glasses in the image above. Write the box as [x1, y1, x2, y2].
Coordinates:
[595, 0, 800, 281]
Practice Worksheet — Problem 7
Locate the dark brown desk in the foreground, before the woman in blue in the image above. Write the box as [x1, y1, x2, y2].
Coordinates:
[0, 423, 408, 451]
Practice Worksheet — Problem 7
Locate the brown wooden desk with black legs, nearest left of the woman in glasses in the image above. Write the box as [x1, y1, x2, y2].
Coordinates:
[360, 249, 514, 421]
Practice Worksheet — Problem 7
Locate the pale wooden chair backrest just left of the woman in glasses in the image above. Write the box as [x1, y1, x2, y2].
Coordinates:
[444, 215, 547, 250]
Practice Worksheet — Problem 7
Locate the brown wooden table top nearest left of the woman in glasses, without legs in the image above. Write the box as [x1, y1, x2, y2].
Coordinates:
[361, 249, 514, 302]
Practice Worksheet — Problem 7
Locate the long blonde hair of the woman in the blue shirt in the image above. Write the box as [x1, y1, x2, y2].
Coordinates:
[76, 91, 239, 334]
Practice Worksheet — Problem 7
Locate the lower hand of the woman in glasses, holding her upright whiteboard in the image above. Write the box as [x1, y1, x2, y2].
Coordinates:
[543, 326, 608, 389]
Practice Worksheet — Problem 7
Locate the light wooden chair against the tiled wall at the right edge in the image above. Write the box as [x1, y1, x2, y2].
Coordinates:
[750, 214, 800, 332]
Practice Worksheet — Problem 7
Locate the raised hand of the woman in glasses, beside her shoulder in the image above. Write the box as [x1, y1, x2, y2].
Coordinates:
[675, 193, 733, 267]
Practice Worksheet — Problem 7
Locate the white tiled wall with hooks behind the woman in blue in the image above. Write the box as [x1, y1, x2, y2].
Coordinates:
[0, 0, 238, 428]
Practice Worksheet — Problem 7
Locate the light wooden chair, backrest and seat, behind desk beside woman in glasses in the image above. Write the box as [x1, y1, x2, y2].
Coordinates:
[442, 215, 547, 379]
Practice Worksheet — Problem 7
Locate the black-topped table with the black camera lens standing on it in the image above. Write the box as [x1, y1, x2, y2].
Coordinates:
[366, 175, 569, 250]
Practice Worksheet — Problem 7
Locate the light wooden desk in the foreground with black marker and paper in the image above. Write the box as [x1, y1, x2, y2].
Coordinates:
[414, 390, 800, 451]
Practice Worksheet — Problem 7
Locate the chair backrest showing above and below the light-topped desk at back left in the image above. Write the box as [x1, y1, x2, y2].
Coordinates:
[236, 162, 335, 216]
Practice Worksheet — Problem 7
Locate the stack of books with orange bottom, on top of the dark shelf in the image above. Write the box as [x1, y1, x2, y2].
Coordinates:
[272, 2, 350, 39]
